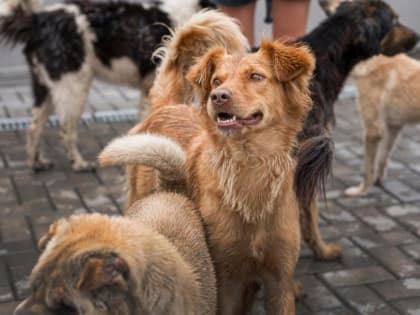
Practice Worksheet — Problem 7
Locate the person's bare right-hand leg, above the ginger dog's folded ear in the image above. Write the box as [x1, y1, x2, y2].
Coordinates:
[272, 0, 309, 40]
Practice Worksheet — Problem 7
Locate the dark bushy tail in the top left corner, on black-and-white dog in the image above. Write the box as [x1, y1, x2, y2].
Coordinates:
[0, 0, 40, 45]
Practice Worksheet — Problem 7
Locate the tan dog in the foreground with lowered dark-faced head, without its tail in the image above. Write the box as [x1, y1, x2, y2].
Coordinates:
[14, 193, 216, 315]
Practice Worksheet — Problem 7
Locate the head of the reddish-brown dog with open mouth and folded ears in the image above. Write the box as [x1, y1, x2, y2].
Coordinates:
[187, 40, 314, 141]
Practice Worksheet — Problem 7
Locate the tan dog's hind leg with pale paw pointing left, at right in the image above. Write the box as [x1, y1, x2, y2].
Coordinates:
[345, 128, 382, 197]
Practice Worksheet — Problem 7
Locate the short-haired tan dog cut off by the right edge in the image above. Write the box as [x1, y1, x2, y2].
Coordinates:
[345, 54, 420, 196]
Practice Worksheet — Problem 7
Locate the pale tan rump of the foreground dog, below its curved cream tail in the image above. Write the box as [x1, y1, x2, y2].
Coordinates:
[126, 193, 216, 315]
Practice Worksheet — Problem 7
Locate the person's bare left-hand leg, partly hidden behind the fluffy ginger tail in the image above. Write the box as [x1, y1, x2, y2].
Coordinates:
[218, 2, 255, 46]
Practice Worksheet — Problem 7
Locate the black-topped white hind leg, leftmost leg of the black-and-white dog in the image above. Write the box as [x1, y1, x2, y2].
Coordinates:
[26, 73, 53, 172]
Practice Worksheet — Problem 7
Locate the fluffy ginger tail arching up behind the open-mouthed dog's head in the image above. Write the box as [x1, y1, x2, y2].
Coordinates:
[150, 10, 249, 106]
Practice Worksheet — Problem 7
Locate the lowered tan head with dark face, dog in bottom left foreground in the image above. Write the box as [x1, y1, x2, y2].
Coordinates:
[14, 214, 135, 315]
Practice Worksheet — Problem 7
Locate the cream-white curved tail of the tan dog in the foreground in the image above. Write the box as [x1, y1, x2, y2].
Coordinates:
[98, 133, 186, 184]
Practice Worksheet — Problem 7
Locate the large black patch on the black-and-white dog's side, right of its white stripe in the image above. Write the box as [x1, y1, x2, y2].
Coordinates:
[67, 0, 173, 76]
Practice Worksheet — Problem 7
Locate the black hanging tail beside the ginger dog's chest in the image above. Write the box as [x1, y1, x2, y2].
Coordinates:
[294, 134, 334, 208]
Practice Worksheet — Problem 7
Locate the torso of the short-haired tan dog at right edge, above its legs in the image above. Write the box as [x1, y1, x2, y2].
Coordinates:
[352, 54, 420, 126]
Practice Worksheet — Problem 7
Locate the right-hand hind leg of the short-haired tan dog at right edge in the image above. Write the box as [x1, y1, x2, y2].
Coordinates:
[374, 125, 402, 184]
